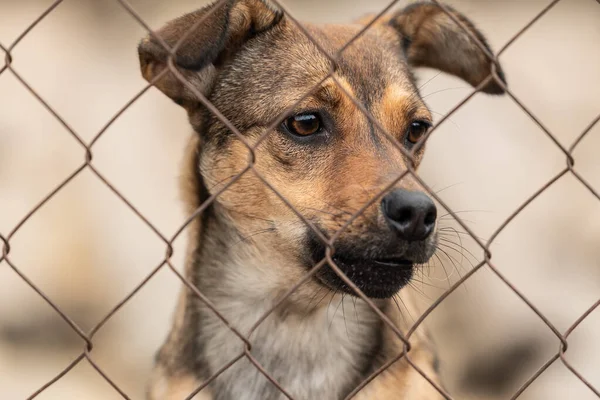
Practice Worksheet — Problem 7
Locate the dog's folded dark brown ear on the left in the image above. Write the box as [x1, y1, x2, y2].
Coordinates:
[138, 0, 283, 106]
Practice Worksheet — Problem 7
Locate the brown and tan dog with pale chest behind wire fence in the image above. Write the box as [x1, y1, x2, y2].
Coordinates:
[138, 0, 506, 400]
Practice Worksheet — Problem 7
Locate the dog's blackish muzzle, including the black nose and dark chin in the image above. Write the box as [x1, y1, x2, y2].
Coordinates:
[309, 189, 437, 298]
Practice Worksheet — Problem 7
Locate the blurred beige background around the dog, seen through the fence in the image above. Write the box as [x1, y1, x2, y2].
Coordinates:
[0, 0, 600, 400]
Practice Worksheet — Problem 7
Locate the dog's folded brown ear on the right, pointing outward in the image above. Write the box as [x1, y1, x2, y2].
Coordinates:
[388, 3, 506, 94]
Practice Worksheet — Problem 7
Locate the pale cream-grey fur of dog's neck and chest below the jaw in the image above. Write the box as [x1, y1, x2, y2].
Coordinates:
[188, 210, 390, 400]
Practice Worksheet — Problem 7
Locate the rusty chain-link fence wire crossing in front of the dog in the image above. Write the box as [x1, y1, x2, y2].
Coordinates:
[0, 0, 600, 399]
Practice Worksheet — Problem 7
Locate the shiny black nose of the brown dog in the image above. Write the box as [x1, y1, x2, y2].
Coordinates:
[381, 189, 437, 241]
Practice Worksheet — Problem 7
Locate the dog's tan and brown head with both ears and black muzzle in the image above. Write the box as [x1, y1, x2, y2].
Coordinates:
[139, 0, 503, 297]
